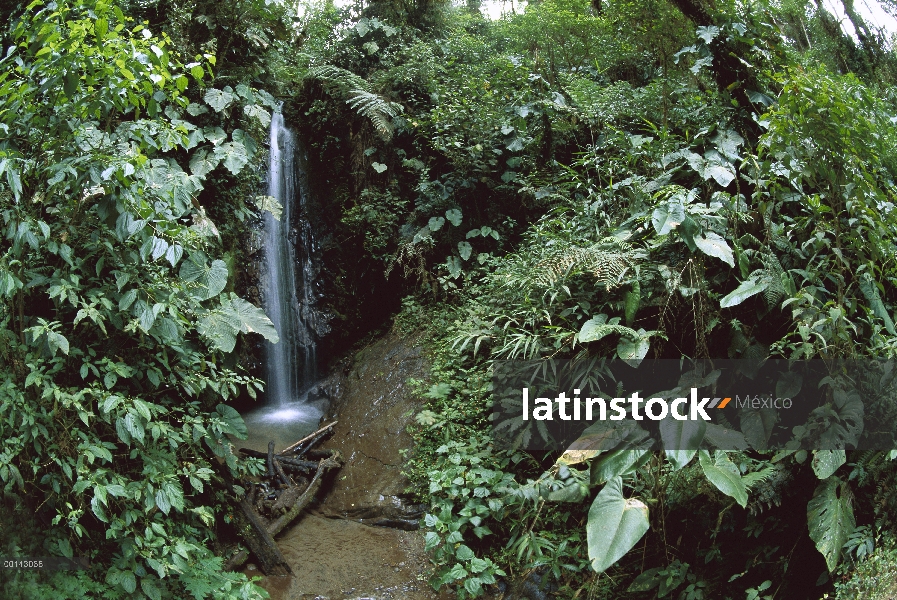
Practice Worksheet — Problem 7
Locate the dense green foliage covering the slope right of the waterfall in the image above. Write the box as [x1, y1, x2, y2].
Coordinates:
[294, 0, 897, 599]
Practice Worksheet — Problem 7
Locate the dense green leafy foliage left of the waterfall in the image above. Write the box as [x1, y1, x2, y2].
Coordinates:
[0, 0, 288, 598]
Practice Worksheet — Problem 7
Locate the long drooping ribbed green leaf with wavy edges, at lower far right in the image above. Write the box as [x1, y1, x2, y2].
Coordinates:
[807, 477, 856, 571]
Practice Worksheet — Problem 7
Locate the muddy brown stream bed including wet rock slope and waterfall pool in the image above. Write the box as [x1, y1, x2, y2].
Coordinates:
[238, 332, 453, 600]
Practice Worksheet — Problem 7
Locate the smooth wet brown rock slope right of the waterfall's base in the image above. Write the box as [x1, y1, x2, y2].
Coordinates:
[314, 331, 428, 530]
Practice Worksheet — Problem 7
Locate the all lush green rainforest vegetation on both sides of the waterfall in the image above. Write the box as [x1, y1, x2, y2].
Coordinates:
[0, 0, 897, 600]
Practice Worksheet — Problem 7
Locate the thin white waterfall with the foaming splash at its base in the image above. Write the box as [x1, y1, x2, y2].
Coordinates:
[244, 112, 322, 445]
